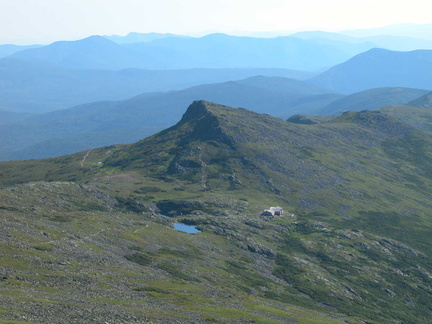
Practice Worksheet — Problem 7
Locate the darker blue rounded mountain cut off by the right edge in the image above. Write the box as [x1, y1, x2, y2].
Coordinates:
[309, 49, 432, 94]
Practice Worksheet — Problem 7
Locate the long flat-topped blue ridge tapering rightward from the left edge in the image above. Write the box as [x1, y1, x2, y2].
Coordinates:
[0, 58, 311, 113]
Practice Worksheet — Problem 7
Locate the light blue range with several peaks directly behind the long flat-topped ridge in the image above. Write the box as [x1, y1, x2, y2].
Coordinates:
[11, 34, 374, 71]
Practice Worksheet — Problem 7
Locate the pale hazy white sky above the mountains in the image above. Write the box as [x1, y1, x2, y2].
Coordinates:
[0, 0, 432, 44]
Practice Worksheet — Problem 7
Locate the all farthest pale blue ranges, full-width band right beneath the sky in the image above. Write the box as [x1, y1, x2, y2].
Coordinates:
[5, 24, 432, 71]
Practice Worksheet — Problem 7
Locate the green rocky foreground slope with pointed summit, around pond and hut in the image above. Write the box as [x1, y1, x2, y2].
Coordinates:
[0, 101, 432, 323]
